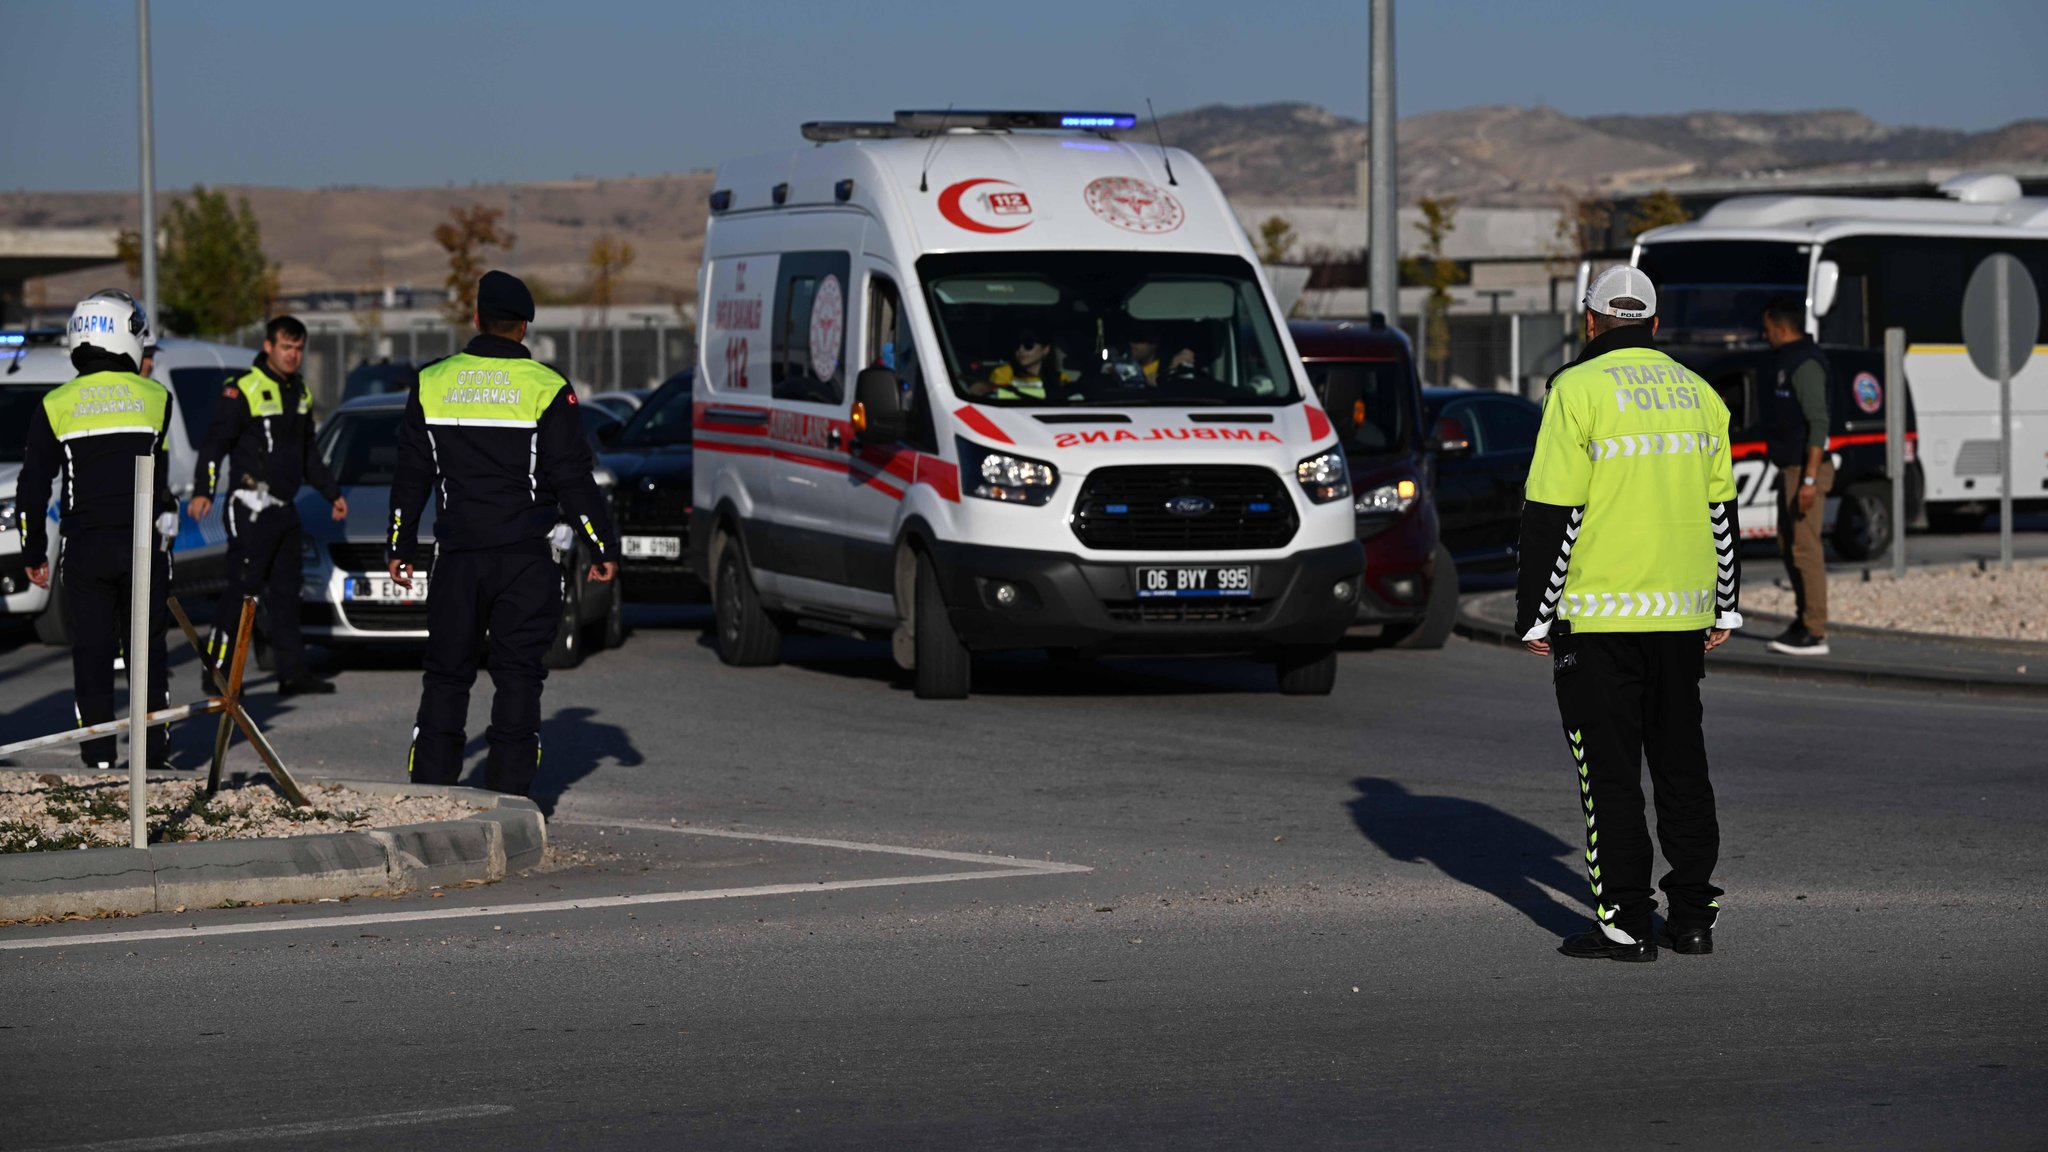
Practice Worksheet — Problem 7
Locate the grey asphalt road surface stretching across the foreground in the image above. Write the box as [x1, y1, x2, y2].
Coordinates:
[0, 611, 2048, 1152]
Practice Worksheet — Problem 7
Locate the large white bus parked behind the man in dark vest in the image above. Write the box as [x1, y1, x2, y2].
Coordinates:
[1634, 174, 2048, 531]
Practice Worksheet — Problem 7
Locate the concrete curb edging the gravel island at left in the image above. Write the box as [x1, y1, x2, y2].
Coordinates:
[0, 781, 547, 920]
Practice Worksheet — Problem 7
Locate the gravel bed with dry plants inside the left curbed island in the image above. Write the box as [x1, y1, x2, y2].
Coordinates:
[0, 773, 479, 853]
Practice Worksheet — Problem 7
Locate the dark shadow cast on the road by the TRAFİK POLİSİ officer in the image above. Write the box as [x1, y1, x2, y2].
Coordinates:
[1346, 777, 1587, 937]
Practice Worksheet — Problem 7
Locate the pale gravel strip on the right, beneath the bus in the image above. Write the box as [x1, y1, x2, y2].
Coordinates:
[1743, 564, 2048, 642]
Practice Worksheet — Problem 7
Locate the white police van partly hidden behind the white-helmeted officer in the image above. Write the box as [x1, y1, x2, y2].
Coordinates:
[0, 330, 254, 644]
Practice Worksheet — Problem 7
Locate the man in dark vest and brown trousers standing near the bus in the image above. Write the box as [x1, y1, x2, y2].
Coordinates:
[1763, 295, 1835, 656]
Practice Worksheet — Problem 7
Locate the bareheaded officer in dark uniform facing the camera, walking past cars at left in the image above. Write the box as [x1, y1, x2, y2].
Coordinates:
[190, 316, 348, 695]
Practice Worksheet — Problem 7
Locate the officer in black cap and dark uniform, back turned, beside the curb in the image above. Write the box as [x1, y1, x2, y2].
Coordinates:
[391, 273, 618, 795]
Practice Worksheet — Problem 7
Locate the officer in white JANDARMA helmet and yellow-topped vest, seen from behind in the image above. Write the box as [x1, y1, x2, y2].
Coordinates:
[14, 289, 178, 769]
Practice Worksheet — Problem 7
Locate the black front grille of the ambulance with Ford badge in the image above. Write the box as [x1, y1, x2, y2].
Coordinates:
[1073, 463, 1298, 551]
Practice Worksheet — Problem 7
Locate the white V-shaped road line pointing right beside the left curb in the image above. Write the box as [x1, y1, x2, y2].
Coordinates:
[0, 820, 1094, 951]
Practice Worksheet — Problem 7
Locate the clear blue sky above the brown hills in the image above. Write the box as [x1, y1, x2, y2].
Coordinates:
[0, 0, 2048, 189]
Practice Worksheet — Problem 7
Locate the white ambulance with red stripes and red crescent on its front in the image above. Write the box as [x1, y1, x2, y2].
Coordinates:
[690, 111, 1364, 697]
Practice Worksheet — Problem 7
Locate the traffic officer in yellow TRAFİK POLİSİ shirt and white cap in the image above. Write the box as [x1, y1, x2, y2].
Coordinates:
[1516, 266, 1743, 961]
